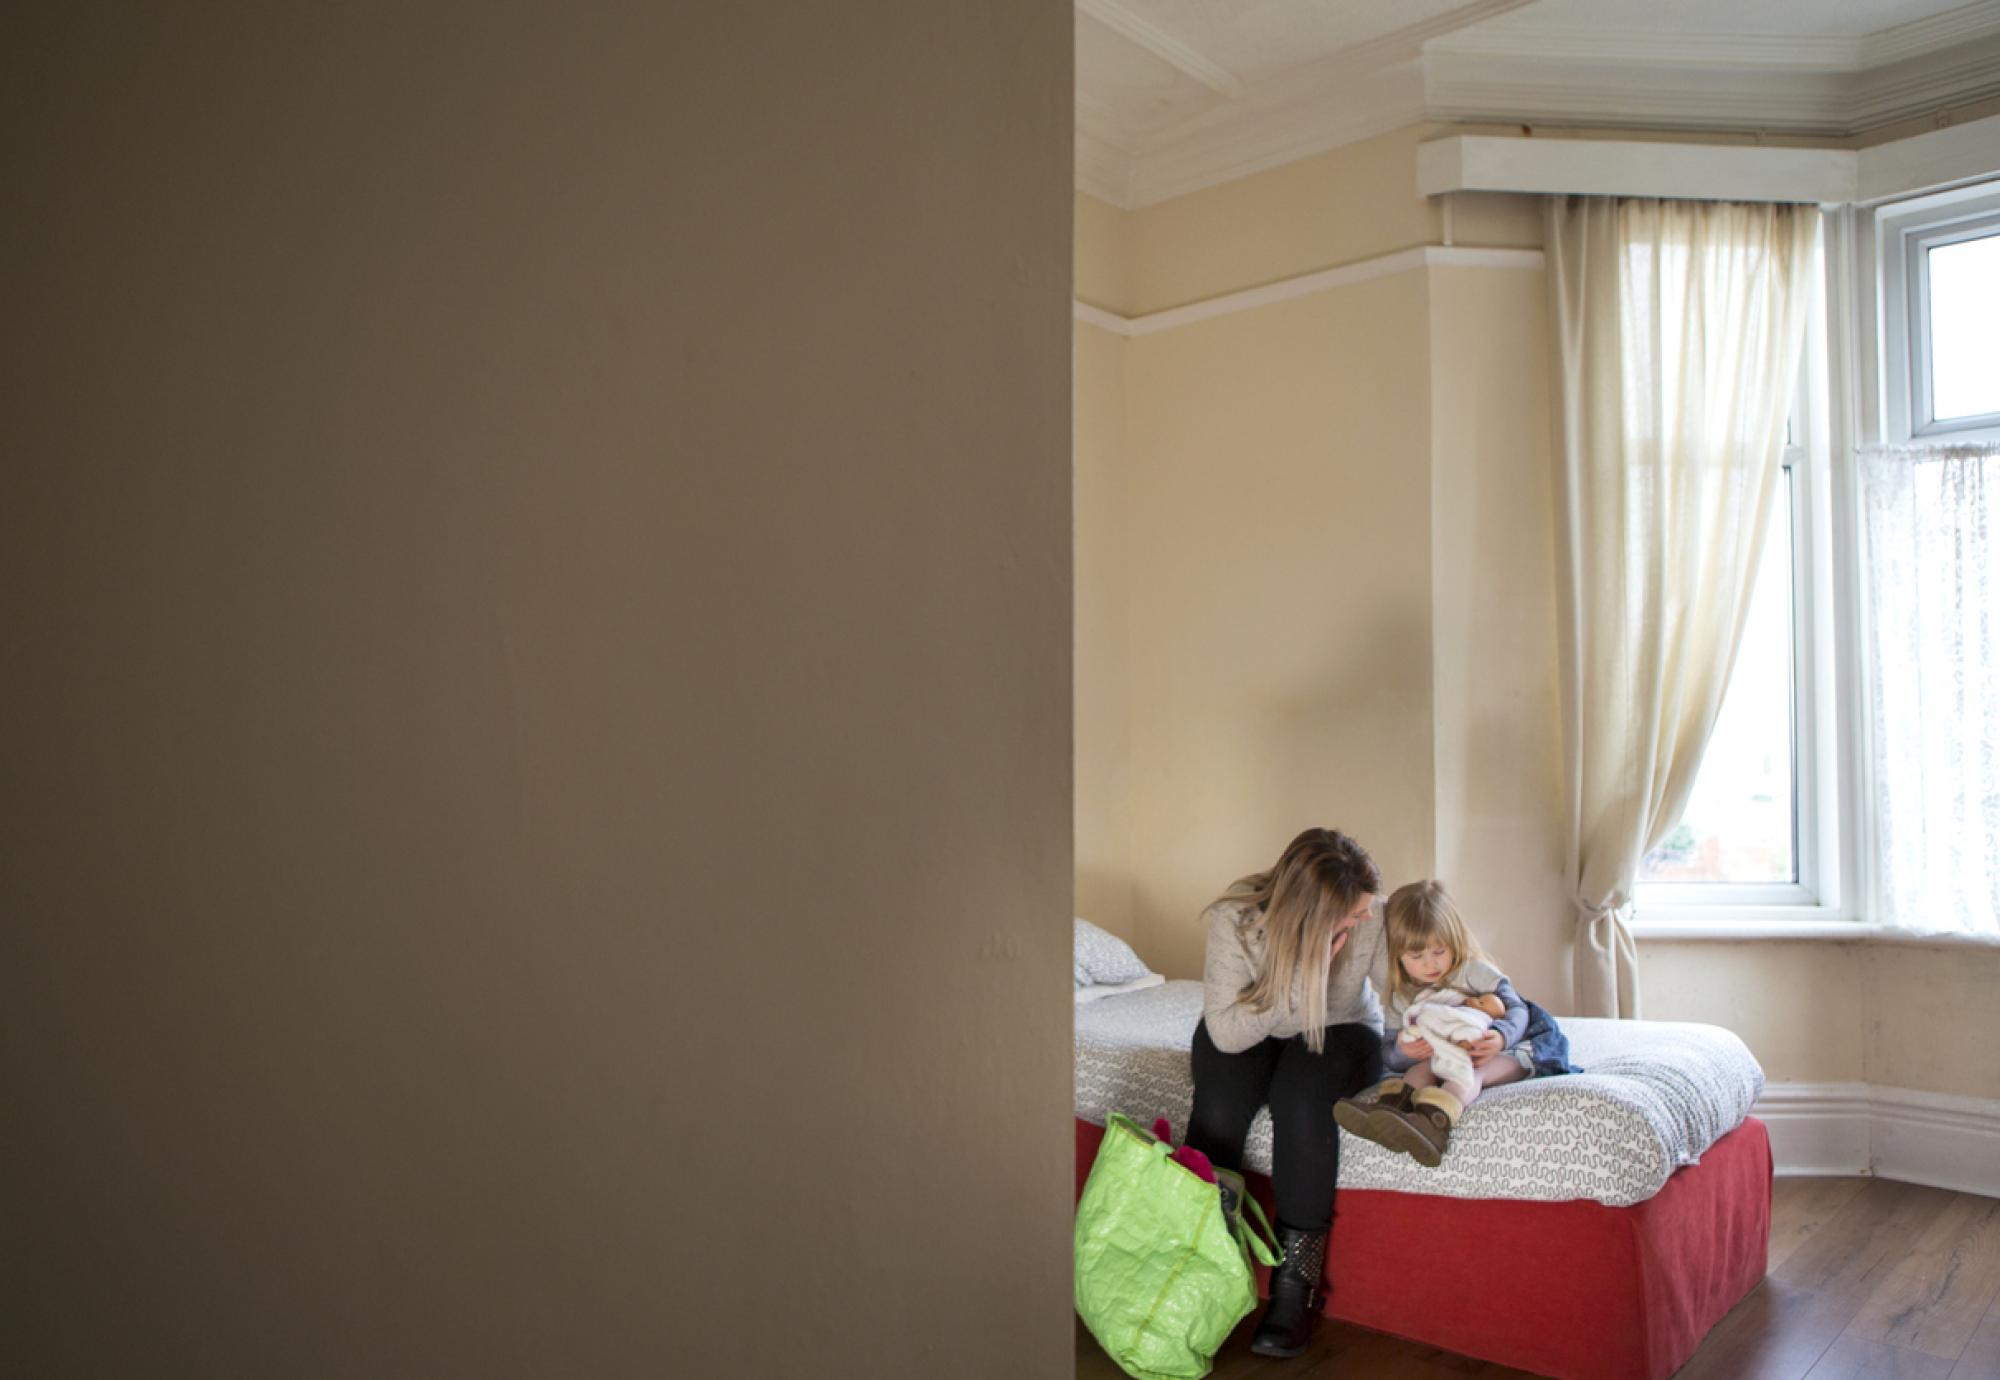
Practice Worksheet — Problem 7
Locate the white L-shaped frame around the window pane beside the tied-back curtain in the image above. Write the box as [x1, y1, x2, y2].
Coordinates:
[1634, 242, 1856, 938]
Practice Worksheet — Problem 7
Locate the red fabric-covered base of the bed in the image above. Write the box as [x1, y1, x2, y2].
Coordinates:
[1076, 1118, 1770, 1380]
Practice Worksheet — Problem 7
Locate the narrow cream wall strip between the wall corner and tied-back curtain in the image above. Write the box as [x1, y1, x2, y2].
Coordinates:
[1430, 268, 1570, 1010]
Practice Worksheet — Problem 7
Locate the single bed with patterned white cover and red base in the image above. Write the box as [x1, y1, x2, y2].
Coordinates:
[1076, 982, 1770, 1380]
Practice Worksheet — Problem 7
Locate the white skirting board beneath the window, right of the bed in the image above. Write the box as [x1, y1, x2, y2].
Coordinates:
[1750, 1082, 2000, 1198]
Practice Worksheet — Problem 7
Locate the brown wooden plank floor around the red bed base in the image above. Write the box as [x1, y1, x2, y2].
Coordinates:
[1076, 1178, 2000, 1380]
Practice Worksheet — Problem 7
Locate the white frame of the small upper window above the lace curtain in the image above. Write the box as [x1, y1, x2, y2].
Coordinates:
[1874, 182, 2000, 442]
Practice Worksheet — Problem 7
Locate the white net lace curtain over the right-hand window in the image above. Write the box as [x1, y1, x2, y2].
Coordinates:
[1860, 444, 2000, 934]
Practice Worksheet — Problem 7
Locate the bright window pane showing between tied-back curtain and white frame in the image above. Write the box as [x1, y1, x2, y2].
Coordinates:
[1640, 470, 1798, 884]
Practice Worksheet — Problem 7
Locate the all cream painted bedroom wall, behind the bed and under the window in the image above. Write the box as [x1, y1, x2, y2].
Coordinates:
[1078, 130, 2000, 1098]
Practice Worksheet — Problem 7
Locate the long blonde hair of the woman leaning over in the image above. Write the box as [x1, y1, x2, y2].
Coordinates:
[1222, 828, 1382, 1054]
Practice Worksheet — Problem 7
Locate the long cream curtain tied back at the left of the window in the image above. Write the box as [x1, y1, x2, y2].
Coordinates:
[1546, 196, 1820, 1018]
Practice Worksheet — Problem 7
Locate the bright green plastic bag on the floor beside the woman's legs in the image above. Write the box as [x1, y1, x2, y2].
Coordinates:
[1076, 1112, 1278, 1380]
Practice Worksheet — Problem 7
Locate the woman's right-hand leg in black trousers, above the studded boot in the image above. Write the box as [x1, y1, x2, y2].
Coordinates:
[1270, 1026, 1382, 1232]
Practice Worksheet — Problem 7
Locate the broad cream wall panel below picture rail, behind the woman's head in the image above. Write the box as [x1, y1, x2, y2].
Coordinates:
[1126, 274, 1434, 974]
